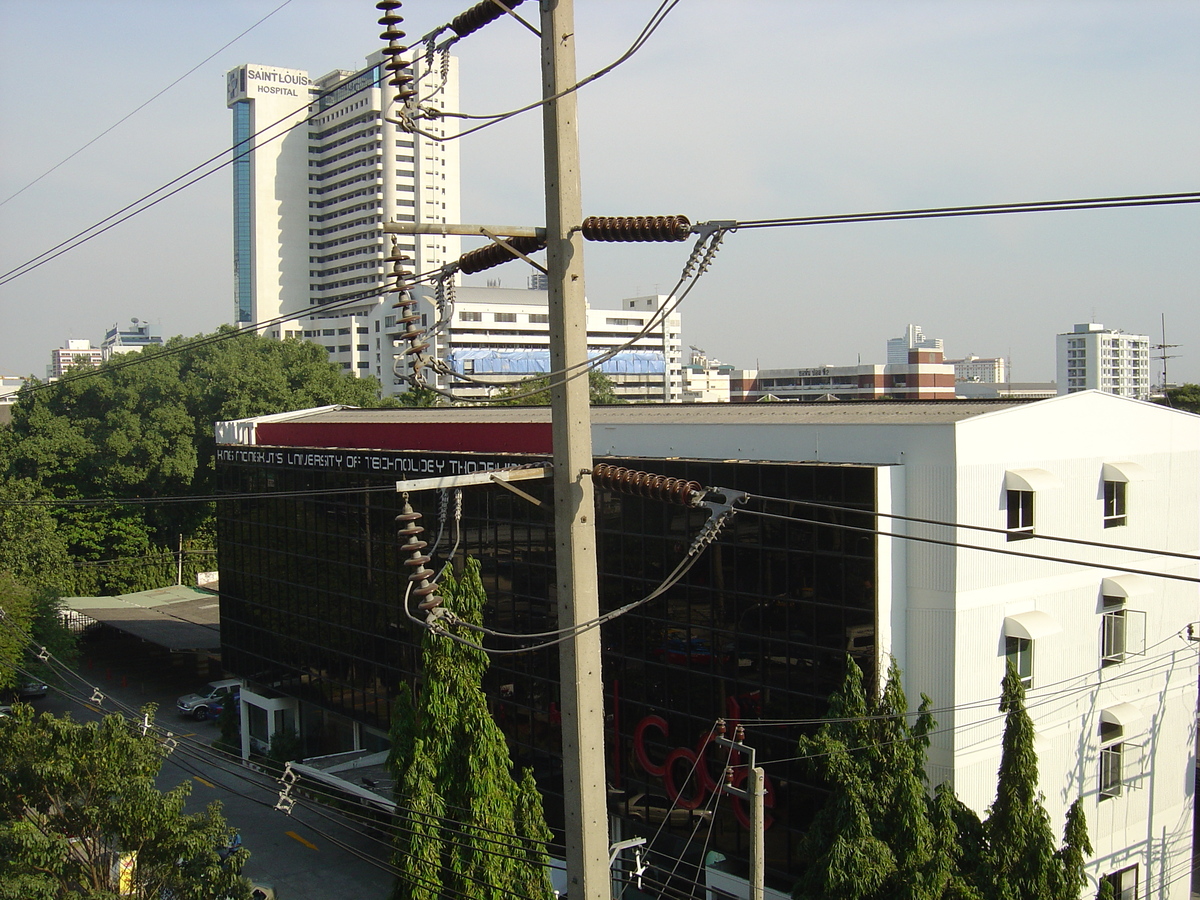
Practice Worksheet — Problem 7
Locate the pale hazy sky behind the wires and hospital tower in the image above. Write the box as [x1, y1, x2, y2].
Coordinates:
[0, 0, 1200, 382]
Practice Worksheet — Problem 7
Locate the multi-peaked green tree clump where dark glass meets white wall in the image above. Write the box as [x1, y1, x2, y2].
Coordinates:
[792, 658, 970, 900]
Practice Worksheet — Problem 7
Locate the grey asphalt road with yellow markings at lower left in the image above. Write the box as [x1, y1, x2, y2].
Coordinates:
[32, 642, 392, 900]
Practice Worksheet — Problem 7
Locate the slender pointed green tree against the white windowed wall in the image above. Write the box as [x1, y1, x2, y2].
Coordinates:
[978, 662, 1092, 900]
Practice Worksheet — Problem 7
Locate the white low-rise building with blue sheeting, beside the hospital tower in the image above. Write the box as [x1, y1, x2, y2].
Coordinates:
[405, 287, 683, 403]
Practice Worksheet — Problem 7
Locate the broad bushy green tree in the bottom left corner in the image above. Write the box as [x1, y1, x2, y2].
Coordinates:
[0, 704, 251, 900]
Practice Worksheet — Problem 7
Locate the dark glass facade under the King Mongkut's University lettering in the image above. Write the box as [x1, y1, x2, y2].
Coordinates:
[217, 446, 878, 888]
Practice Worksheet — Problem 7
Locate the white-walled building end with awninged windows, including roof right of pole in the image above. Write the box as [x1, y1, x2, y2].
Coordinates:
[593, 391, 1200, 900]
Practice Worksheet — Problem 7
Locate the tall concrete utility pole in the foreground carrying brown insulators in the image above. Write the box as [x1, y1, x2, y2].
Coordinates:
[541, 0, 611, 900]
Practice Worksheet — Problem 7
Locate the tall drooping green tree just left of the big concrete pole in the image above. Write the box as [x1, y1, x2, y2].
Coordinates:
[389, 559, 553, 900]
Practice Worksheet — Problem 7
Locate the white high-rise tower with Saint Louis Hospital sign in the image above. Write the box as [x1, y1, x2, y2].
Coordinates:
[226, 53, 458, 394]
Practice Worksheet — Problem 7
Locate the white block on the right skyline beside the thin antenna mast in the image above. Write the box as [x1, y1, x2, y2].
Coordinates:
[1055, 322, 1150, 400]
